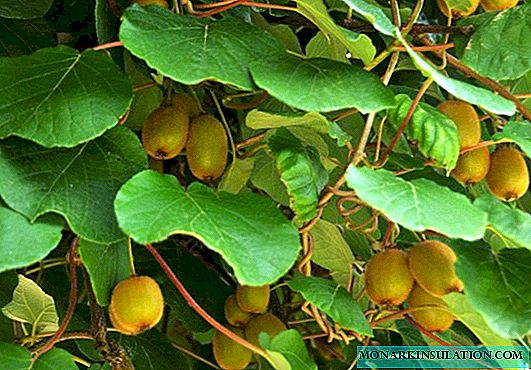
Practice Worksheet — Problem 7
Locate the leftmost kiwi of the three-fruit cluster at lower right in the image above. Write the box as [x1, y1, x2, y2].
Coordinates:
[365, 249, 413, 306]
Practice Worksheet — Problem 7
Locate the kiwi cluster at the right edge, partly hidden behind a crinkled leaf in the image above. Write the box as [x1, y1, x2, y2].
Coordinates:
[437, 100, 529, 201]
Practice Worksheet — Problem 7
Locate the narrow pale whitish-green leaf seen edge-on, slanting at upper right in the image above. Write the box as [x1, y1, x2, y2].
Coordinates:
[397, 35, 516, 116]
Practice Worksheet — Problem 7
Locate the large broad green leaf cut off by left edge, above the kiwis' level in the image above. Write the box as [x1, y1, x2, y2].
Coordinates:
[0, 46, 132, 147]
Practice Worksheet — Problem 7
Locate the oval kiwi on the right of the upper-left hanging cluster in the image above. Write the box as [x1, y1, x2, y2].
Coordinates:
[186, 114, 229, 182]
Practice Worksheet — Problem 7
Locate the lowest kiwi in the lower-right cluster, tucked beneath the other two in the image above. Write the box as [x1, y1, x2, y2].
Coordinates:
[408, 284, 454, 332]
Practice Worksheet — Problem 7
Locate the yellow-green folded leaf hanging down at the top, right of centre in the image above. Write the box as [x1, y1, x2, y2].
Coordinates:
[295, 0, 376, 64]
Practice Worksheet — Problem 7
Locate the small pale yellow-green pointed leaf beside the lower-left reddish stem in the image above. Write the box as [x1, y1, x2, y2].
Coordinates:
[2, 275, 59, 334]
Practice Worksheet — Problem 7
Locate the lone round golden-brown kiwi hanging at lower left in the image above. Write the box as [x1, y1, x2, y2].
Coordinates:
[109, 276, 164, 335]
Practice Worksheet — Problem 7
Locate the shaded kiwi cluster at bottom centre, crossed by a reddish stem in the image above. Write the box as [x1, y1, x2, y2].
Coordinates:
[212, 285, 287, 370]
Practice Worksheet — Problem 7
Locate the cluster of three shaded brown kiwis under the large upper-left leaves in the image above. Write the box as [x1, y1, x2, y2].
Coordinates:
[142, 93, 228, 182]
